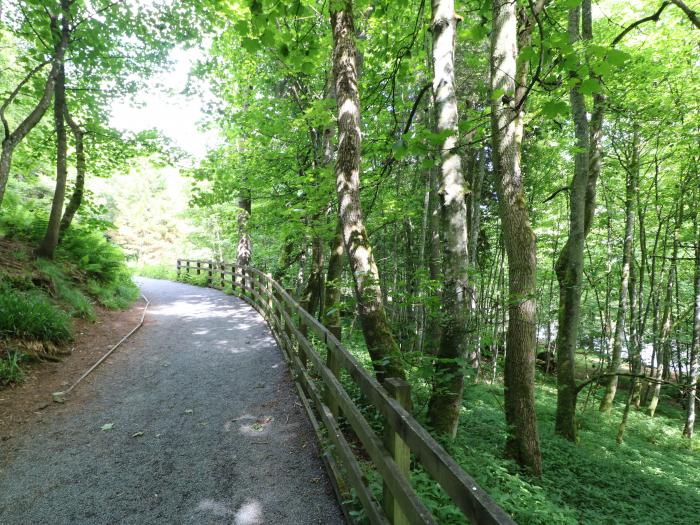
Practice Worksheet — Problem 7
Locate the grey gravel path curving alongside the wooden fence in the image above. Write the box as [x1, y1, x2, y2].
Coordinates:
[0, 279, 344, 525]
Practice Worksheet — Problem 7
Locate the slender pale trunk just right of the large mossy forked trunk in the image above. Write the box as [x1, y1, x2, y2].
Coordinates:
[600, 126, 639, 412]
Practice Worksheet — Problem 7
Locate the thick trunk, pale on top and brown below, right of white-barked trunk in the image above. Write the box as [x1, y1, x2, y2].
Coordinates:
[491, 0, 542, 475]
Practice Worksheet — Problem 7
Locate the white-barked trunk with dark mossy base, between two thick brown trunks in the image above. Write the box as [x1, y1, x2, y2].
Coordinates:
[428, 0, 469, 437]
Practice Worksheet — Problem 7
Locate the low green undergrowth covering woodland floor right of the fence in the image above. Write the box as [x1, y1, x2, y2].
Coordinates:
[336, 332, 700, 525]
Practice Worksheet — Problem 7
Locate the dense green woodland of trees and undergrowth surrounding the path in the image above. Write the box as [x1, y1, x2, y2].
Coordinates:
[0, 0, 700, 524]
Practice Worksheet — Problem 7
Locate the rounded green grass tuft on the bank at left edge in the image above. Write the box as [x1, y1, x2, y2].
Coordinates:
[0, 286, 71, 344]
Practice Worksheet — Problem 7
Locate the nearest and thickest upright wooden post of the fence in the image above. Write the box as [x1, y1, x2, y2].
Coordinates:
[382, 377, 411, 525]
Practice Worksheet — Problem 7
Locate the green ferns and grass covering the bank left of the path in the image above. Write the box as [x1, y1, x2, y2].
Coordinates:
[0, 188, 139, 385]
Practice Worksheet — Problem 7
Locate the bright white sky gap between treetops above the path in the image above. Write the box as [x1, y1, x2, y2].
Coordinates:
[110, 49, 218, 159]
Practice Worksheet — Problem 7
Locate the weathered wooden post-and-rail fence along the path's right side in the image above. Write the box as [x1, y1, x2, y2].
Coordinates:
[177, 259, 515, 525]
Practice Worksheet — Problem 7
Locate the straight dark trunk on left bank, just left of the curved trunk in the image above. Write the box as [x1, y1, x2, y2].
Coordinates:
[36, 64, 68, 259]
